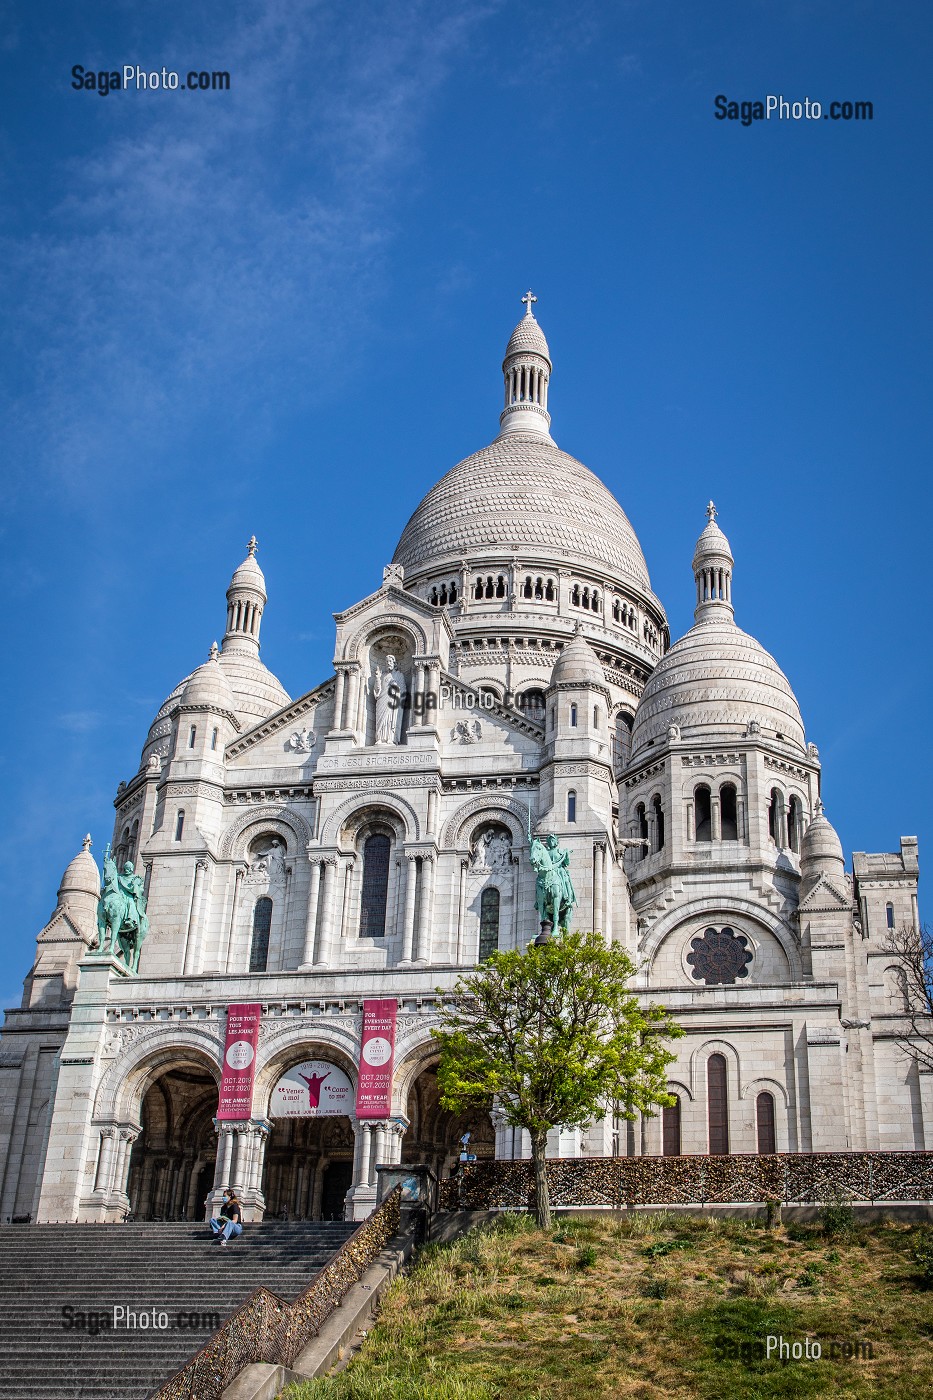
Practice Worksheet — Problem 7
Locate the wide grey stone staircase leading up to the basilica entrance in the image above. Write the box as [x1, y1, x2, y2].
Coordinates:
[0, 1221, 357, 1400]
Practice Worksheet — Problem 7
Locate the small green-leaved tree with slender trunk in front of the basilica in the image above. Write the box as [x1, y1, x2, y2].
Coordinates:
[434, 934, 684, 1229]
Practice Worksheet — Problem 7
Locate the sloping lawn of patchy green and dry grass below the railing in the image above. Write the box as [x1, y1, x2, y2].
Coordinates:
[284, 1208, 933, 1400]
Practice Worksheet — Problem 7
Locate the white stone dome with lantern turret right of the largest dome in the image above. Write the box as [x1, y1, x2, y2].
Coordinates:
[632, 501, 806, 757]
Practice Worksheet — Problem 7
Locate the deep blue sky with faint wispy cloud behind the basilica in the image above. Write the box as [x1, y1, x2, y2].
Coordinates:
[0, 0, 933, 1005]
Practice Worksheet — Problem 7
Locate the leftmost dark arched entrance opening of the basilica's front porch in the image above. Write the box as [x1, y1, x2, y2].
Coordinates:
[126, 1064, 217, 1221]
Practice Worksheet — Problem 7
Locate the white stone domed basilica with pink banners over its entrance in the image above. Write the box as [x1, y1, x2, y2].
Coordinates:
[0, 294, 918, 1224]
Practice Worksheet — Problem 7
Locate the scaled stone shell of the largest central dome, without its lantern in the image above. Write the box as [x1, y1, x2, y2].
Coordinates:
[392, 433, 651, 591]
